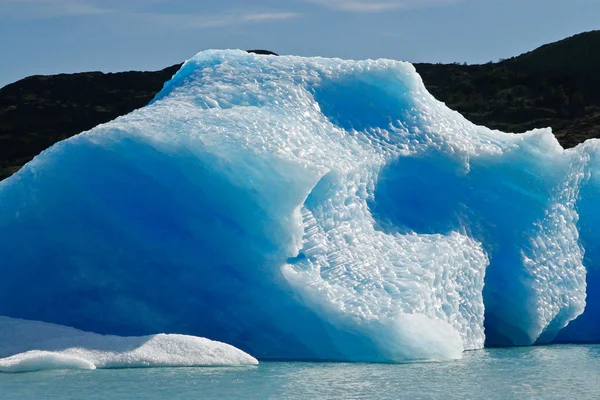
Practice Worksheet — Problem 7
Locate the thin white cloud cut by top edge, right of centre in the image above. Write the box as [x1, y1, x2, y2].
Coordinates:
[304, 0, 459, 13]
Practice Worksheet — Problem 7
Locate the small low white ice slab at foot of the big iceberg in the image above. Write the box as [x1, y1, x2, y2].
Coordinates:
[0, 317, 258, 372]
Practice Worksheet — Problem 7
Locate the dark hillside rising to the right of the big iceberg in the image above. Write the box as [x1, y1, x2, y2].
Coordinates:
[415, 31, 600, 147]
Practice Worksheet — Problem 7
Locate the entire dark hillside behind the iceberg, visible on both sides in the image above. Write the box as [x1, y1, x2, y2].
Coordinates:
[0, 31, 600, 179]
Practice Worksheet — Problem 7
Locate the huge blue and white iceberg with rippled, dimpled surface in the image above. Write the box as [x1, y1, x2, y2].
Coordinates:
[0, 51, 600, 361]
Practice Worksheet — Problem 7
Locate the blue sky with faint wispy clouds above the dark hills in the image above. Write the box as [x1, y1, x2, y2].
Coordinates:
[0, 0, 600, 87]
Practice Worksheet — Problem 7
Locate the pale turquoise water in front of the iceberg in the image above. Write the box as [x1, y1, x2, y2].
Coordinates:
[0, 345, 600, 400]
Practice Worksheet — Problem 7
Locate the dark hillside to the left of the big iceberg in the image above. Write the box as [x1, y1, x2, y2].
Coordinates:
[0, 66, 179, 180]
